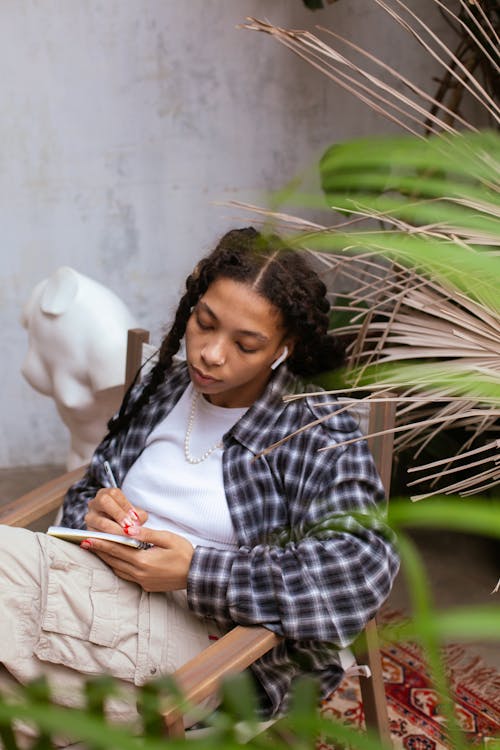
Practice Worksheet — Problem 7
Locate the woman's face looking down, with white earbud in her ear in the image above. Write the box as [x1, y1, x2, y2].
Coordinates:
[186, 278, 291, 407]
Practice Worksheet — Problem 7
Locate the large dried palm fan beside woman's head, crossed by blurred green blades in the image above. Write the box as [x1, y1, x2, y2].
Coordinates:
[227, 160, 500, 498]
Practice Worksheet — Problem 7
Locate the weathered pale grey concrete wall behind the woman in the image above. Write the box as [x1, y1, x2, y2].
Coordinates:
[0, 0, 454, 467]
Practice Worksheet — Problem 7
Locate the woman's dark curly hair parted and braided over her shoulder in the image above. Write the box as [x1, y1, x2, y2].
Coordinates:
[108, 227, 344, 435]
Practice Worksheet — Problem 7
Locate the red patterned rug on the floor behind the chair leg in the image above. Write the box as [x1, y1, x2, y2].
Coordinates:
[317, 644, 500, 750]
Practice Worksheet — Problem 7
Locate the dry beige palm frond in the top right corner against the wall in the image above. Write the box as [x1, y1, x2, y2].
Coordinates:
[244, 0, 500, 137]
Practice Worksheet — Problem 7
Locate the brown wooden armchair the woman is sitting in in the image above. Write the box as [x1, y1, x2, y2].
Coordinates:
[0, 329, 394, 747]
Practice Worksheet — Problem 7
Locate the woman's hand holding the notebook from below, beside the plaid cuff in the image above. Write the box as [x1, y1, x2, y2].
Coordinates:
[82, 526, 194, 591]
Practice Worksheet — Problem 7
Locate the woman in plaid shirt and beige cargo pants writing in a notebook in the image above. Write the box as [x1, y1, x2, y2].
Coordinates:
[0, 229, 397, 716]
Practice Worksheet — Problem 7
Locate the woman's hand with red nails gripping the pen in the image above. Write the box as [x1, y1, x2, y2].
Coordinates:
[85, 487, 148, 536]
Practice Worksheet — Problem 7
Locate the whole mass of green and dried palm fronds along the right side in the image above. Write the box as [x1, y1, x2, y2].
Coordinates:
[240, 5, 500, 497]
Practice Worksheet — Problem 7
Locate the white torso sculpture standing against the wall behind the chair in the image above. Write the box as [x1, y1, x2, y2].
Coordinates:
[22, 266, 136, 469]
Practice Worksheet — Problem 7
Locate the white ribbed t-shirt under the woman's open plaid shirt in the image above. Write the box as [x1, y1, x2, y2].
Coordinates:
[121, 384, 247, 549]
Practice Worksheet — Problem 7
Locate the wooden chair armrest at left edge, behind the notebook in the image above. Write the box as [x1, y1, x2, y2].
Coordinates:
[0, 466, 85, 526]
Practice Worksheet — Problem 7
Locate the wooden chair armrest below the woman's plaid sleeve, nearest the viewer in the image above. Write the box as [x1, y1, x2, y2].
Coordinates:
[163, 626, 281, 737]
